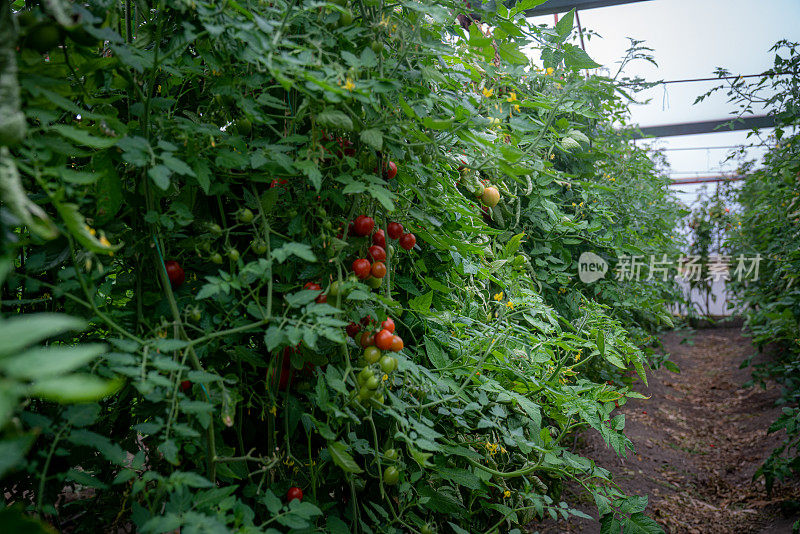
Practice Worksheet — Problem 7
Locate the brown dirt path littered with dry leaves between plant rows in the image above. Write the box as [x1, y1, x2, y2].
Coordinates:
[533, 328, 800, 534]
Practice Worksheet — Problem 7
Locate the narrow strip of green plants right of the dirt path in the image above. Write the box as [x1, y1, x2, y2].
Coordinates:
[712, 41, 800, 498]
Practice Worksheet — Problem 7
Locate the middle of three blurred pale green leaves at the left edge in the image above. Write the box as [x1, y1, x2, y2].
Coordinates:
[0, 343, 106, 380]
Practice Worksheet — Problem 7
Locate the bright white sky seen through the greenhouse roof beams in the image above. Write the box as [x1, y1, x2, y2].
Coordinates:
[533, 0, 800, 207]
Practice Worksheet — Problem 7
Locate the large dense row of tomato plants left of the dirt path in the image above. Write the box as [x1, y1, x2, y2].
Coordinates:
[0, 0, 680, 533]
